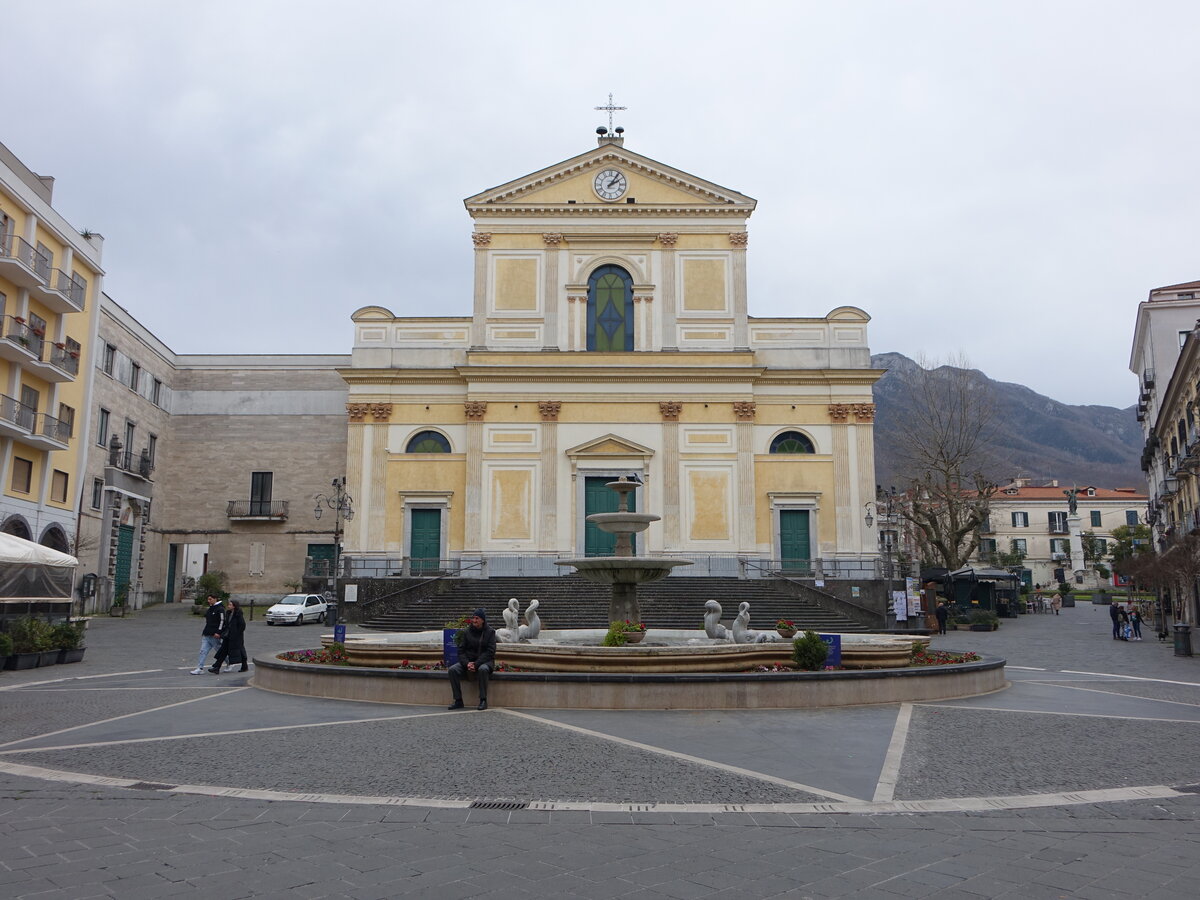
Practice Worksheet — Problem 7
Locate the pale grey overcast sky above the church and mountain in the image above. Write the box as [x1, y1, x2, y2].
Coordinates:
[0, 0, 1200, 407]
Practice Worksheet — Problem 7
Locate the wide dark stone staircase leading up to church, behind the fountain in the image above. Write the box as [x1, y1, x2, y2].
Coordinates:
[362, 575, 869, 632]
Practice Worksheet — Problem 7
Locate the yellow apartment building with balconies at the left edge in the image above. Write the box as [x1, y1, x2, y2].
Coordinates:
[0, 138, 103, 552]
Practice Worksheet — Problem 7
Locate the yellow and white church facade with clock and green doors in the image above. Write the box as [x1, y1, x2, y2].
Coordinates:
[341, 136, 881, 577]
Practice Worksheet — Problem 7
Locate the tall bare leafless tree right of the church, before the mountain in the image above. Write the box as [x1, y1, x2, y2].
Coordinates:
[898, 358, 996, 571]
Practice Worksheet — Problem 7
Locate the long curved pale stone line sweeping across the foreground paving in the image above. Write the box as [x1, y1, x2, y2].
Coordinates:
[0, 757, 1190, 815]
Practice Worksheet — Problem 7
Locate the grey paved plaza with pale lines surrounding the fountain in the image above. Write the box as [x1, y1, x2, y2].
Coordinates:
[0, 605, 1200, 900]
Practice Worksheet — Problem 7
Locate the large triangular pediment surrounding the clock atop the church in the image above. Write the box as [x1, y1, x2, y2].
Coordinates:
[463, 144, 756, 216]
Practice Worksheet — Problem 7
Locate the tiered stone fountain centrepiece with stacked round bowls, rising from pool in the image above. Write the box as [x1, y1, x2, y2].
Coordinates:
[554, 475, 692, 622]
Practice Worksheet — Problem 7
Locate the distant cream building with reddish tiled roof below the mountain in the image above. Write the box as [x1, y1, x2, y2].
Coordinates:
[974, 478, 1146, 587]
